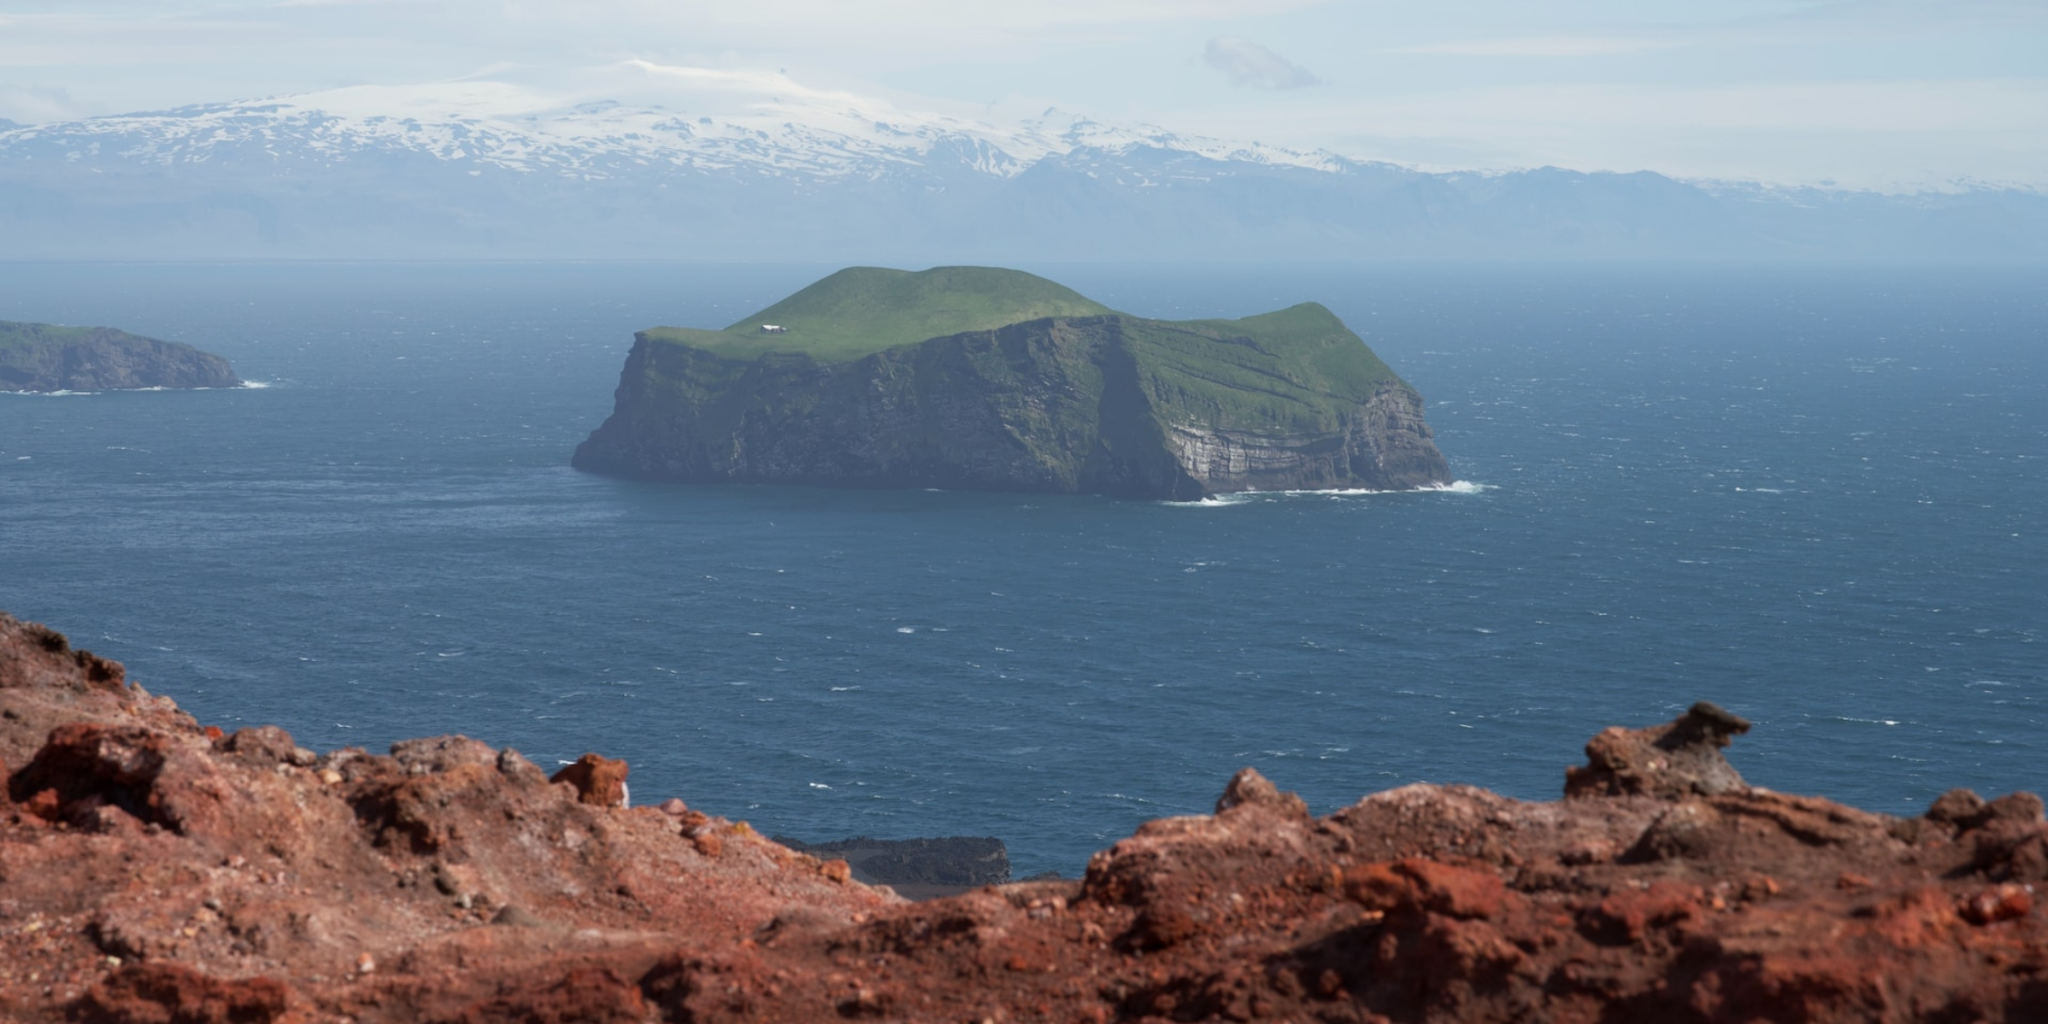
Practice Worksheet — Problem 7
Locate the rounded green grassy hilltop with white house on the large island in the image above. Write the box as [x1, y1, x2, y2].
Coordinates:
[645, 266, 1110, 362]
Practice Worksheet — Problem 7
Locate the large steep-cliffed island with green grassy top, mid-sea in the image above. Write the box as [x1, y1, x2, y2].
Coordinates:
[573, 266, 1452, 500]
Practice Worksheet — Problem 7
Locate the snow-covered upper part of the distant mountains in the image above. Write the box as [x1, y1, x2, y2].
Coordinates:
[6, 61, 1346, 180]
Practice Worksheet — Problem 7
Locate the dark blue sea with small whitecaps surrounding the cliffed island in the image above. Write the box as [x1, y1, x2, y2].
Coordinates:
[0, 264, 2048, 874]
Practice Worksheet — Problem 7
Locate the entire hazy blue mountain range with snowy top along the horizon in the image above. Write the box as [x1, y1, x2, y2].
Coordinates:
[0, 74, 2048, 262]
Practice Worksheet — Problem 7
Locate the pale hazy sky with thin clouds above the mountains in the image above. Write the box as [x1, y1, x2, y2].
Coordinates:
[0, 0, 2048, 190]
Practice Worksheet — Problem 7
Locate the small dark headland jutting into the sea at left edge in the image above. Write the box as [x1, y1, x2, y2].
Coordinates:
[0, 319, 242, 391]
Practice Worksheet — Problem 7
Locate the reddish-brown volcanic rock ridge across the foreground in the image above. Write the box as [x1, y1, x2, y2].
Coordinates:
[0, 614, 2048, 1022]
